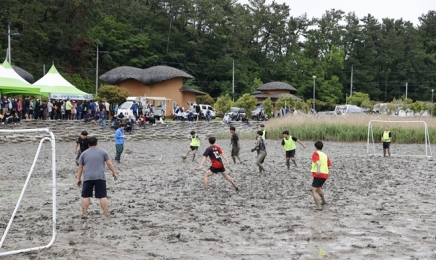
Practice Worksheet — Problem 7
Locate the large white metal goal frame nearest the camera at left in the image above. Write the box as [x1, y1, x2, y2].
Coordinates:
[0, 128, 56, 257]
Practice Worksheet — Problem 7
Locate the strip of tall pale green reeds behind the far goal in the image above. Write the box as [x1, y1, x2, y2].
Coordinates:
[217, 114, 436, 143]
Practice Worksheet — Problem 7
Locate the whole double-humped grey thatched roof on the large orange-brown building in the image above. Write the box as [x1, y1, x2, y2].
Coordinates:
[100, 66, 194, 86]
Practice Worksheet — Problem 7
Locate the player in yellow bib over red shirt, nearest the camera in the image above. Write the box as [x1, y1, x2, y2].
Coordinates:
[312, 141, 332, 210]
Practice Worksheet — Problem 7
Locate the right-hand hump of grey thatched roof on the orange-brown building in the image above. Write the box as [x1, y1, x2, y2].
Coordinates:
[141, 66, 194, 85]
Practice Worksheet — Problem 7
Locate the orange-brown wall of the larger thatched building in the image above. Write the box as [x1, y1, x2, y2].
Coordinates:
[118, 78, 190, 116]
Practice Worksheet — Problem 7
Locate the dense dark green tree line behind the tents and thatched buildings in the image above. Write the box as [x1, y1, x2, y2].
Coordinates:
[0, 0, 436, 110]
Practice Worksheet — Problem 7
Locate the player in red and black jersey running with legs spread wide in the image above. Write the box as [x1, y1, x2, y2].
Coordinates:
[198, 137, 239, 191]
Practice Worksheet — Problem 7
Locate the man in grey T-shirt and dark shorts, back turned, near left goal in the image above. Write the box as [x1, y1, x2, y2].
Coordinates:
[77, 136, 117, 217]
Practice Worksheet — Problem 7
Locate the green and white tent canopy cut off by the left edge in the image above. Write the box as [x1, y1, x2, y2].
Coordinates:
[0, 61, 40, 95]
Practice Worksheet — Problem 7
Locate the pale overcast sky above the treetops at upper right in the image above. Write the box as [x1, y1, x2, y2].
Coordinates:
[238, 0, 436, 25]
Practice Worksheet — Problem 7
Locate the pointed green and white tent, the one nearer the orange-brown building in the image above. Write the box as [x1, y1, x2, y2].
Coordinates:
[33, 65, 92, 100]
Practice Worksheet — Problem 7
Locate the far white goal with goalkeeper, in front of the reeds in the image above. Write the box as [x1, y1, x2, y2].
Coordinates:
[366, 120, 432, 157]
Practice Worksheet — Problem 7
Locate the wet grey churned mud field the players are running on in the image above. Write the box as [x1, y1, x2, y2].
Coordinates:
[0, 123, 436, 259]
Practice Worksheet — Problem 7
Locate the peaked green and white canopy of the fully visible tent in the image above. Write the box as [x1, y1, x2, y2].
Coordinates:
[33, 65, 89, 96]
